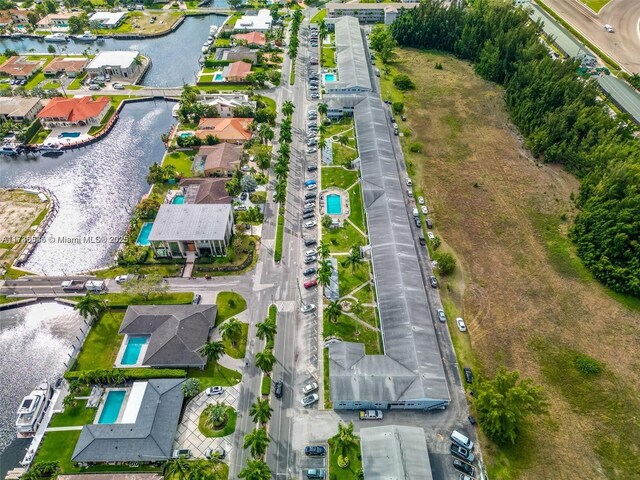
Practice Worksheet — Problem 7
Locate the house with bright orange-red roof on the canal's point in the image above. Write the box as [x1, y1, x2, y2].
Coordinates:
[38, 97, 111, 128]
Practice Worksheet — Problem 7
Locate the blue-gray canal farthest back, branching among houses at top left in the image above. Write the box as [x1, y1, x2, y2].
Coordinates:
[0, 12, 227, 87]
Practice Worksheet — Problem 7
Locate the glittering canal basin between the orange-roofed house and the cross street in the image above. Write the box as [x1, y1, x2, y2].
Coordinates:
[0, 100, 175, 276]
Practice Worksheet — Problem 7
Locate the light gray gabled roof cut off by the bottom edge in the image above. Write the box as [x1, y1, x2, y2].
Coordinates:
[360, 425, 433, 480]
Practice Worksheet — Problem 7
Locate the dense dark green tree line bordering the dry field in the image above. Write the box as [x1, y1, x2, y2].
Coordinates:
[391, 0, 640, 296]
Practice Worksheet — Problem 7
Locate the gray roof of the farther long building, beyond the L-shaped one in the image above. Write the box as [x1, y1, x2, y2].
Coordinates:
[334, 17, 371, 90]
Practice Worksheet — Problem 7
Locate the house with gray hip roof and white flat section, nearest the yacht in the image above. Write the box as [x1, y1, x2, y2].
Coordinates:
[71, 378, 184, 466]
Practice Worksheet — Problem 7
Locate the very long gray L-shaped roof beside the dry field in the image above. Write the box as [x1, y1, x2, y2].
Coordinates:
[329, 94, 450, 403]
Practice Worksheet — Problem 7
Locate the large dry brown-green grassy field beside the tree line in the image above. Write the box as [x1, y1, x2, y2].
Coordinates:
[383, 50, 640, 480]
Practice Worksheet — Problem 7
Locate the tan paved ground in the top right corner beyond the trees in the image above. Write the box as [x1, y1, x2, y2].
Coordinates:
[545, 0, 640, 73]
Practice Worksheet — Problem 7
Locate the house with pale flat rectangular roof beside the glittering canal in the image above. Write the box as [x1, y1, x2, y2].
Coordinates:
[149, 203, 233, 258]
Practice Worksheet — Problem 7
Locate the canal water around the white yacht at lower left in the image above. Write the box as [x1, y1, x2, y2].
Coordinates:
[0, 302, 87, 478]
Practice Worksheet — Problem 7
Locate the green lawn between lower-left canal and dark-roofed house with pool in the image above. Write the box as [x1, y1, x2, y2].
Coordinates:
[73, 312, 125, 371]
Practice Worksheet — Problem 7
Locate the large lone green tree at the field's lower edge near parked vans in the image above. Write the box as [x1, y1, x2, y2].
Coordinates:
[474, 368, 547, 445]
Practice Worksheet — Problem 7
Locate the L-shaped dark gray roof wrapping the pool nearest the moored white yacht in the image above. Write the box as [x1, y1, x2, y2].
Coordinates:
[71, 379, 184, 462]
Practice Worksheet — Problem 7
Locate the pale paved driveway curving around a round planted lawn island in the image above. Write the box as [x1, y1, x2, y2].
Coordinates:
[173, 386, 238, 462]
